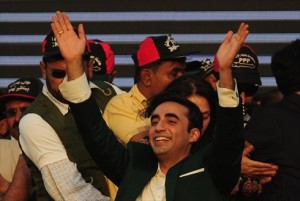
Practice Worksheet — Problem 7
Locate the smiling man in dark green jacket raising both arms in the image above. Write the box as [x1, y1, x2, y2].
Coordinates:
[51, 12, 249, 201]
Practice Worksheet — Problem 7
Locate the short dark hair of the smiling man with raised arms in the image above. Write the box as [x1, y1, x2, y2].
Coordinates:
[144, 92, 203, 132]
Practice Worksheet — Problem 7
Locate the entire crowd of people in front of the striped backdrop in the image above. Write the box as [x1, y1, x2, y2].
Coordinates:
[0, 11, 300, 201]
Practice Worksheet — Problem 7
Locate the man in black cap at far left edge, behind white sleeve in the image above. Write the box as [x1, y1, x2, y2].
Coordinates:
[0, 77, 43, 201]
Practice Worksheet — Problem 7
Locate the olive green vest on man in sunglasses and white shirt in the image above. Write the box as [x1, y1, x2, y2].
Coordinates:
[23, 84, 116, 200]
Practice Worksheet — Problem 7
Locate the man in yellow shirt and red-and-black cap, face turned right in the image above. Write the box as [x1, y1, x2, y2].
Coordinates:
[103, 35, 186, 145]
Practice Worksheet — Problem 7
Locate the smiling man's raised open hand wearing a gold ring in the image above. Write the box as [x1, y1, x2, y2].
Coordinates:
[51, 11, 86, 80]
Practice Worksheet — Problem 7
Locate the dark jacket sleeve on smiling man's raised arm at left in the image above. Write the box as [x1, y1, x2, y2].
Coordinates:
[70, 96, 129, 185]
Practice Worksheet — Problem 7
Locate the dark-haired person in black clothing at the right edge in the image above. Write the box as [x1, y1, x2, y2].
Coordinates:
[244, 39, 300, 201]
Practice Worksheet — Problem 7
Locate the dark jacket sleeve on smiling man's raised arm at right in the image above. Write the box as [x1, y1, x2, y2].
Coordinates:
[208, 105, 245, 194]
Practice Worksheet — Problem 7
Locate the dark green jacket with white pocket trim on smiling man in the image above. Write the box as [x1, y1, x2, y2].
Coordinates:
[70, 95, 244, 201]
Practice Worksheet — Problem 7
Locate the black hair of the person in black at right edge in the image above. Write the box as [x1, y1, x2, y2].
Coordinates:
[271, 39, 300, 95]
